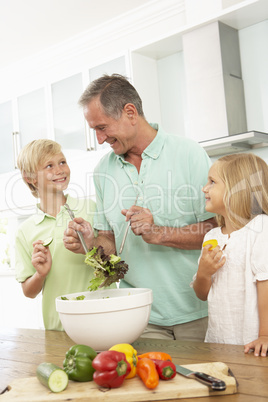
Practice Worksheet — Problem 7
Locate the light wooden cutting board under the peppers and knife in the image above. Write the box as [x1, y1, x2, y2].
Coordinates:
[1, 362, 237, 402]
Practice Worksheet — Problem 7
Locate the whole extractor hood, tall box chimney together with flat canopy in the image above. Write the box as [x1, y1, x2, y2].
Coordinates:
[183, 21, 268, 157]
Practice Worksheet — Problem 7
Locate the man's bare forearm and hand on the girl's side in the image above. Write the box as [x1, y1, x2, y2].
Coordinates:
[122, 206, 217, 250]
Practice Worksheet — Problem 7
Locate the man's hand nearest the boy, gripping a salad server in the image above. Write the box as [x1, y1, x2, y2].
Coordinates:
[63, 218, 94, 254]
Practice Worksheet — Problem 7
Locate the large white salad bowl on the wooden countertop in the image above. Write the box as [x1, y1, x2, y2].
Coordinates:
[56, 288, 153, 352]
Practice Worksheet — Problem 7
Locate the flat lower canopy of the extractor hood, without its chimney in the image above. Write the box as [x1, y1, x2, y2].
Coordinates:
[199, 131, 268, 156]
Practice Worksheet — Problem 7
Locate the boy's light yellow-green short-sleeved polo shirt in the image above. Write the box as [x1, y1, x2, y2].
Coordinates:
[15, 196, 96, 330]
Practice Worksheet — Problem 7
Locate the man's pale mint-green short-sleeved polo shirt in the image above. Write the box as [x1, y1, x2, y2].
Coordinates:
[94, 126, 213, 326]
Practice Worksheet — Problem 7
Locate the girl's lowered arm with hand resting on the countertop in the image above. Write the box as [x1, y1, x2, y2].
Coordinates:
[244, 280, 268, 357]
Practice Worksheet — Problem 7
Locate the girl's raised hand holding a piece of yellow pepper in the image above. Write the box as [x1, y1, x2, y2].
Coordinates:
[198, 244, 226, 277]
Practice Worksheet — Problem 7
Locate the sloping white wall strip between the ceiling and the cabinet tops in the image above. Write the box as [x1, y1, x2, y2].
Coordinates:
[0, 0, 185, 103]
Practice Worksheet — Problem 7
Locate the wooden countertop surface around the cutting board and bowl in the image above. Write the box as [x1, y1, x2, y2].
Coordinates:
[0, 328, 268, 402]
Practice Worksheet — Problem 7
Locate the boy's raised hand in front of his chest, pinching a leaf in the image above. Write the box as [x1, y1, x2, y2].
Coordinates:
[32, 240, 52, 277]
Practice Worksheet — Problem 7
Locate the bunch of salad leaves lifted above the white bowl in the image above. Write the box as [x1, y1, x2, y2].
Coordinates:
[85, 246, 128, 291]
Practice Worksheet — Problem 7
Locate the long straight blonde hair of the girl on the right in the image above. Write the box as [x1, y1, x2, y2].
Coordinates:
[215, 153, 268, 230]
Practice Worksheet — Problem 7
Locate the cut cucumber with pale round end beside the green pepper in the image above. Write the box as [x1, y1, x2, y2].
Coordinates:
[36, 363, 69, 392]
